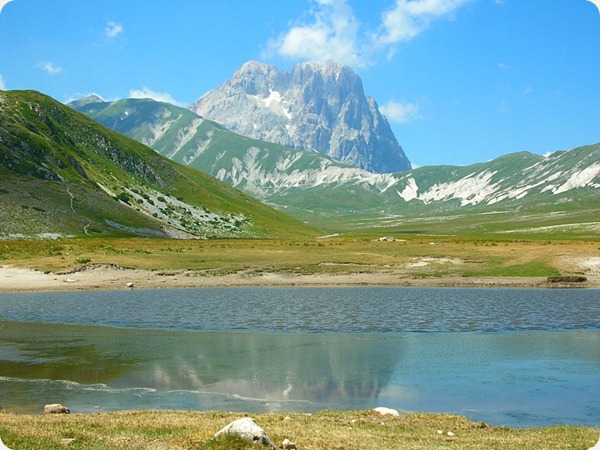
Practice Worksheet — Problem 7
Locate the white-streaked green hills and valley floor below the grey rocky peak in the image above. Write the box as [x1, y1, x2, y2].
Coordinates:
[71, 97, 600, 238]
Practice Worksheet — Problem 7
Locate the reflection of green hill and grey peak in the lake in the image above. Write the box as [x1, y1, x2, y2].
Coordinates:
[0, 322, 402, 410]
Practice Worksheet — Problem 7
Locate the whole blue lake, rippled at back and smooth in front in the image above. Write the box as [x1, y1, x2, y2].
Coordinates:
[0, 288, 600, 426]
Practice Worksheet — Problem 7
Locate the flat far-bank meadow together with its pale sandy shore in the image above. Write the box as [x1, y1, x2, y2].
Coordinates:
[0, 236, 600, 291]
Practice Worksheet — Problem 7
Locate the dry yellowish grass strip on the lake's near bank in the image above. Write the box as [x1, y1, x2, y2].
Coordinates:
[0, 411, 600, 450]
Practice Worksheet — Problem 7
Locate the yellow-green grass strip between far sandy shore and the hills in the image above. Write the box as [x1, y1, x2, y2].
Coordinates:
[0, 236, 600, 277]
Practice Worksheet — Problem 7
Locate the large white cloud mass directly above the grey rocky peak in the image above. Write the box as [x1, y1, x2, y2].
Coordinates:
[267, 0, 475, 67]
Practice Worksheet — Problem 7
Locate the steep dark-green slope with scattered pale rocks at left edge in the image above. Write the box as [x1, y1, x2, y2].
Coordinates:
[0, 91, 313, 238]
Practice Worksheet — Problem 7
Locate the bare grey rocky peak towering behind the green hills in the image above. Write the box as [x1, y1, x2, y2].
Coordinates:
[189, 61, 411, 173]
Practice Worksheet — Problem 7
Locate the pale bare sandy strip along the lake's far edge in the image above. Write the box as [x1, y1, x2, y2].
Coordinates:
[0, 264, 600, 293]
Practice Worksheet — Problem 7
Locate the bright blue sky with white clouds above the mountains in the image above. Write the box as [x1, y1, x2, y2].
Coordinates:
[0, 0, 600, 166]
